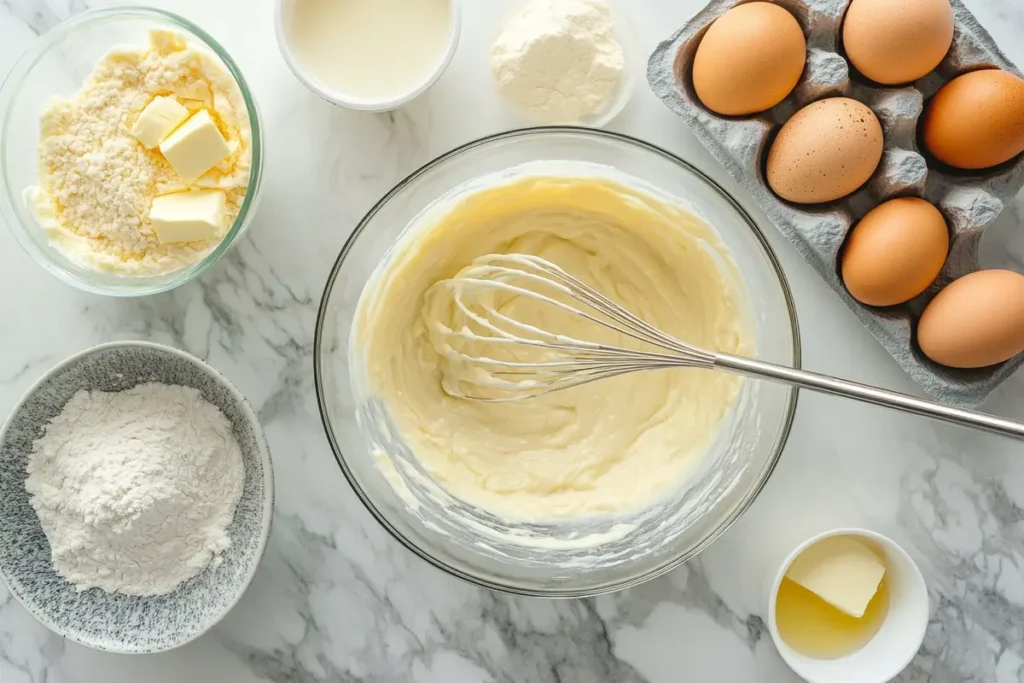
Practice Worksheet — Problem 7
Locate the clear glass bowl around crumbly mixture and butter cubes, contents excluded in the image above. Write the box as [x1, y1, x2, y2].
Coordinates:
[0, 7, 263, 296]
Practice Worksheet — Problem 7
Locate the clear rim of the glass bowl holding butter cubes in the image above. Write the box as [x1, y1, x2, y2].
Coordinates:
[0, 5, 263, 297]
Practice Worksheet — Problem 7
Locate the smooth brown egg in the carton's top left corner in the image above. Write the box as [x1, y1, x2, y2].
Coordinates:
[693, 2, 807, 116]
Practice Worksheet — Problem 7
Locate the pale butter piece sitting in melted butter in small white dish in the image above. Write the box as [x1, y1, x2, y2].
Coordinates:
[785, 536, 886, 618]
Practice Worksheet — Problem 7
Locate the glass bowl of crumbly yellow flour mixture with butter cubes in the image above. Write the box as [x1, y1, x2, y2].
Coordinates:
[0, 7, 263, 296]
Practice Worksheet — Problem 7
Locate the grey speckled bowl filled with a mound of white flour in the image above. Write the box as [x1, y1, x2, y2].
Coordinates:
[0, 342, 273, 653]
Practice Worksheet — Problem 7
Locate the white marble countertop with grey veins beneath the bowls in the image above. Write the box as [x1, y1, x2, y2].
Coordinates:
[0, 0, 1024, 683]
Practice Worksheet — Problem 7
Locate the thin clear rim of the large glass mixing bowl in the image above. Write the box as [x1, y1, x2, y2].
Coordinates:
[313, 126, 802, 598]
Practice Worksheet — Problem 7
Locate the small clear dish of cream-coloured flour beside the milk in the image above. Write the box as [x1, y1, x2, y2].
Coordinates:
[490, 0, 626, 123]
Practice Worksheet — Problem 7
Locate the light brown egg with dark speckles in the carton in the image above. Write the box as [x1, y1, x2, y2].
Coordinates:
[765, 97, 882, 204]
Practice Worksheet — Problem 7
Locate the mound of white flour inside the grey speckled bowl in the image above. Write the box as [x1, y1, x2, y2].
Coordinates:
[26, 384, 244, 595]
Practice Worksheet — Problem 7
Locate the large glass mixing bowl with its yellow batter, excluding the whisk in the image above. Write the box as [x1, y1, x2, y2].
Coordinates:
[313, 127, 800, 597]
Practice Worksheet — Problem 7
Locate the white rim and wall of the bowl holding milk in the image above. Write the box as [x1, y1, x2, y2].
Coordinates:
[273, 0, 462, 112]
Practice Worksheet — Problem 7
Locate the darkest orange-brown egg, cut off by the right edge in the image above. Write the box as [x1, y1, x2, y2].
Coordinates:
[922, 69, 1024, 169]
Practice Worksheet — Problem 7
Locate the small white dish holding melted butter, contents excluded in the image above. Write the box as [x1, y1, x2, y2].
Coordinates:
[767, 528, 929, 683]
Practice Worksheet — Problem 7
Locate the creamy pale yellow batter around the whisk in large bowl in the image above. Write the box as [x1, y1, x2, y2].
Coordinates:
[355, 175, 754, 519]
